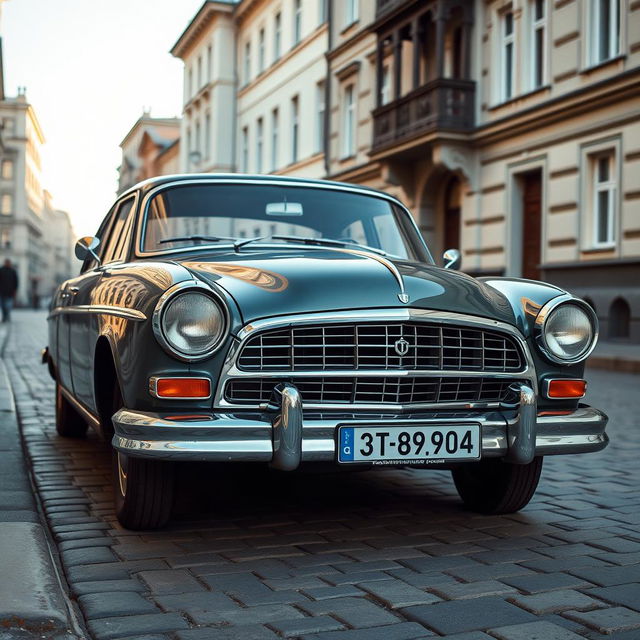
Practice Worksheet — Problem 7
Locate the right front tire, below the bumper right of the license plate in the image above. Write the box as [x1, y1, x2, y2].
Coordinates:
[452, 457, 542, 514]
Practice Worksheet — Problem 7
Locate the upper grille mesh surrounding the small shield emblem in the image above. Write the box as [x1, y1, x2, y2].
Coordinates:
[237, 322, 524, 372]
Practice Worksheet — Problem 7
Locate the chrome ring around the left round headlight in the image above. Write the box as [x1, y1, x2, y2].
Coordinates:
[151, 280, 230, 362]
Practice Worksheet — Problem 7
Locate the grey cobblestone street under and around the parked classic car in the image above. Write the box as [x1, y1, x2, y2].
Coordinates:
[4, 311, 640, 640]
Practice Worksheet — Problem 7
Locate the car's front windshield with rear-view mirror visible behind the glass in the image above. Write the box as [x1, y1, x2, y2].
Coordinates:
[142, 184, 427, 260]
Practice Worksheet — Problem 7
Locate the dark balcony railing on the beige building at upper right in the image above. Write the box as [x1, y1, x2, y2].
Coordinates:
[372, 78, 475, 151]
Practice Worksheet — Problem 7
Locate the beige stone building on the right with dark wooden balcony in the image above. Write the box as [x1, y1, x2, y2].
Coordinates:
[328, 0, 640, 342]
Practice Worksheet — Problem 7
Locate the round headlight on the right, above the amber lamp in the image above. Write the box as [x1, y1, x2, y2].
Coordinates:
[539, 301, 597, 364]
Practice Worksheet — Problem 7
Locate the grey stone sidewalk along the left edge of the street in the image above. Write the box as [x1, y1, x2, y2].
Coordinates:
[0, 325, 78, 640]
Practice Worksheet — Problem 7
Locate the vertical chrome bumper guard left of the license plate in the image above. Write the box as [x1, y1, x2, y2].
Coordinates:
[271, 383, 302, 471]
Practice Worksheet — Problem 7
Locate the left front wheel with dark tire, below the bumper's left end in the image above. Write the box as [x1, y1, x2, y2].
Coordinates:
[113, 451, 175, 531]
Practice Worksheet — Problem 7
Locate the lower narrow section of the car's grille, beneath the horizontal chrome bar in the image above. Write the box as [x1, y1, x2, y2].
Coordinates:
[225, 376, 517, 405]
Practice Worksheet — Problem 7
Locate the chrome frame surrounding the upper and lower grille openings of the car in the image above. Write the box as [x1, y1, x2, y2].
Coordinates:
[213, 308, 538, 411]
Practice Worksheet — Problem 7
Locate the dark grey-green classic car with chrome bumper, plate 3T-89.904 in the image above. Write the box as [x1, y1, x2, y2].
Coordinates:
[43, 174, 608, 529]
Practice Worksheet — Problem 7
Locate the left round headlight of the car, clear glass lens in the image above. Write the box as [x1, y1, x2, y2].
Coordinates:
[156, 290, 227, 360]
